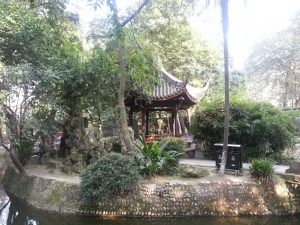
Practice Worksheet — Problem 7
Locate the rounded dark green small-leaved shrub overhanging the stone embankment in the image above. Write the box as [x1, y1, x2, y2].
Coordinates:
[80, 153, 140, 203]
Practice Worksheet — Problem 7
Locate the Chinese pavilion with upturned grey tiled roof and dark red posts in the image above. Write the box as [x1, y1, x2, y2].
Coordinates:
[125, 69, 209, 140]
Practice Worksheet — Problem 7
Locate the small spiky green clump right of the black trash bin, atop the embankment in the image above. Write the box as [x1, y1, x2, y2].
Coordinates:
[250, 159, 274, 180]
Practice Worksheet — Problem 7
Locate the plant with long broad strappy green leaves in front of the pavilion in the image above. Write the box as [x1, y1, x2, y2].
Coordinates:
[135, 137, 181, 176]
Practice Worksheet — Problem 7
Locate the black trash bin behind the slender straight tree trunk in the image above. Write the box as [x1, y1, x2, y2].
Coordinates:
[214, 144, 243, 170]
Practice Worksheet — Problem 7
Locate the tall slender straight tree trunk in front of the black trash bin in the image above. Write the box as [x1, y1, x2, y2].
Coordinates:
[219, 0, 229, 175]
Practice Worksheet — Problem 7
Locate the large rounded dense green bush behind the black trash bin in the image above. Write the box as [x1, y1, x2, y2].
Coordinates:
[192, 96, 295, 159]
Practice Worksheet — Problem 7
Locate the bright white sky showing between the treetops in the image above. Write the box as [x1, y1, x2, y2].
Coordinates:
[69, 0, 300, 70]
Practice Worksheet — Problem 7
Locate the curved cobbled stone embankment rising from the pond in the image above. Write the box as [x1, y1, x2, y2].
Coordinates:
[3, 168, 300, 217]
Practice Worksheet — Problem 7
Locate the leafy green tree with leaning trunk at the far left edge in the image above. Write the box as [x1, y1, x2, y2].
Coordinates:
[0, 0, 85, 172]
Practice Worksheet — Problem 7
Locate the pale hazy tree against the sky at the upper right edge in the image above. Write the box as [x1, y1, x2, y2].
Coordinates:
[246, 14, 300, 108]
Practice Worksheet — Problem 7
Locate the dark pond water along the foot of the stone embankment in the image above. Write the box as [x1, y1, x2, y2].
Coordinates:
[0, 189, 300, 225]
